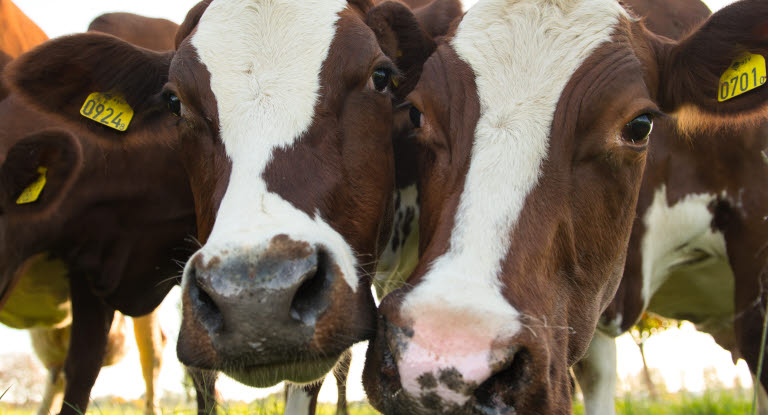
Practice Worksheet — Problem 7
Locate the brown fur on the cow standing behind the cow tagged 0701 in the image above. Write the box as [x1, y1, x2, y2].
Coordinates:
[603, 0, 768, 396]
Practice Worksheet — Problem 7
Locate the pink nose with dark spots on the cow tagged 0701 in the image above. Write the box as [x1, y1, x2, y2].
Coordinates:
[387, 316, 532, 414]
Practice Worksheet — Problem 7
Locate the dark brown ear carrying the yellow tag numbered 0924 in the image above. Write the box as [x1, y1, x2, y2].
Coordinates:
[5, 33, 173, 141]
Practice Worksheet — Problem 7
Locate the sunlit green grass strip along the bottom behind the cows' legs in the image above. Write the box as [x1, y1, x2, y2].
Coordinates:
[0, 391, 751, 415]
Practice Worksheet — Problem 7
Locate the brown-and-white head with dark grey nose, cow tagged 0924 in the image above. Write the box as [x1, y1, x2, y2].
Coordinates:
[10, 0, 459, 386]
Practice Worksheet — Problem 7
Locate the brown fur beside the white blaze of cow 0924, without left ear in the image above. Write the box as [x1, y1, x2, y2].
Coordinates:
[169, 2, 440, 376]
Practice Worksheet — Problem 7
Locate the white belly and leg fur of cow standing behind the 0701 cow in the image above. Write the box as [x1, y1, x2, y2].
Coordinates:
[579, 185, 734, 415]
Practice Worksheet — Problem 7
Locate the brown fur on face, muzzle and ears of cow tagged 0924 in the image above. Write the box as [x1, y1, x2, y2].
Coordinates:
[8, 0, 457, 412]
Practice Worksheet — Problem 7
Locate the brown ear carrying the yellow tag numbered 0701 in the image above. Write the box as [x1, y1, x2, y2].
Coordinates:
[657, 0, 768, 129]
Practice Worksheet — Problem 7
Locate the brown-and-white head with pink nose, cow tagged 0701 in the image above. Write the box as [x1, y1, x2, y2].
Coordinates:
[364, 0, 768, 414]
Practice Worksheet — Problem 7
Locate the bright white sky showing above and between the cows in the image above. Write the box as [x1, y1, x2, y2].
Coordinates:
[0, 0, 751, 402]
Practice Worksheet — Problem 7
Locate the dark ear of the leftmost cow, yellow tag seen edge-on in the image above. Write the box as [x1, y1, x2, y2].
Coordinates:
[0, 129, 83, 215]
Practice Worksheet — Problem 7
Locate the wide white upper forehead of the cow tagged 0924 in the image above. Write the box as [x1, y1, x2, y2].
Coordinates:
[192, 0, 346, 166]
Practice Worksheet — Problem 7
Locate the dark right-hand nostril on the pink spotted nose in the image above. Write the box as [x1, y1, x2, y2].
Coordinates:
[474, 349, 532, 408]
